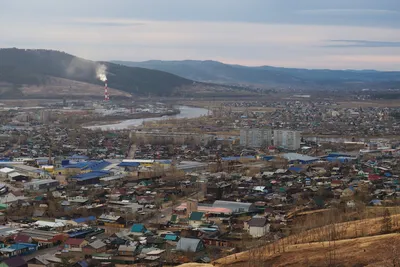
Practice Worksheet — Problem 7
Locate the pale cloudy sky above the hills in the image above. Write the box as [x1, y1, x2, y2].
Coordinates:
[0, 0, 400, 70]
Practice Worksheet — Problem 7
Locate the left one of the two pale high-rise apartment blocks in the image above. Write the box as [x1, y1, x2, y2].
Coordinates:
[240, 128, 272, 148]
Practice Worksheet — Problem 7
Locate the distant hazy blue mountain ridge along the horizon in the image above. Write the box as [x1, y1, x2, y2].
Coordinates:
[113, 60, 400, 88]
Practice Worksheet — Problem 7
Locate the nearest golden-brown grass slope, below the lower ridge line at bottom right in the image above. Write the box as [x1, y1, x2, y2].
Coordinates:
[215, 234, 400, 267]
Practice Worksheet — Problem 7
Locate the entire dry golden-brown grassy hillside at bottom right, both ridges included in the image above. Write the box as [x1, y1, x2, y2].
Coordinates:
[206, 211, 400, 267]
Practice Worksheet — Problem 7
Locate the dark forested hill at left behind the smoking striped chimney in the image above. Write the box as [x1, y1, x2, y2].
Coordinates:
[0, 48, 193, 96]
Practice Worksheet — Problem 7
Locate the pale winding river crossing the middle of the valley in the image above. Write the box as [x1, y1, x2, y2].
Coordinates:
[85, 106, 208, 131]
